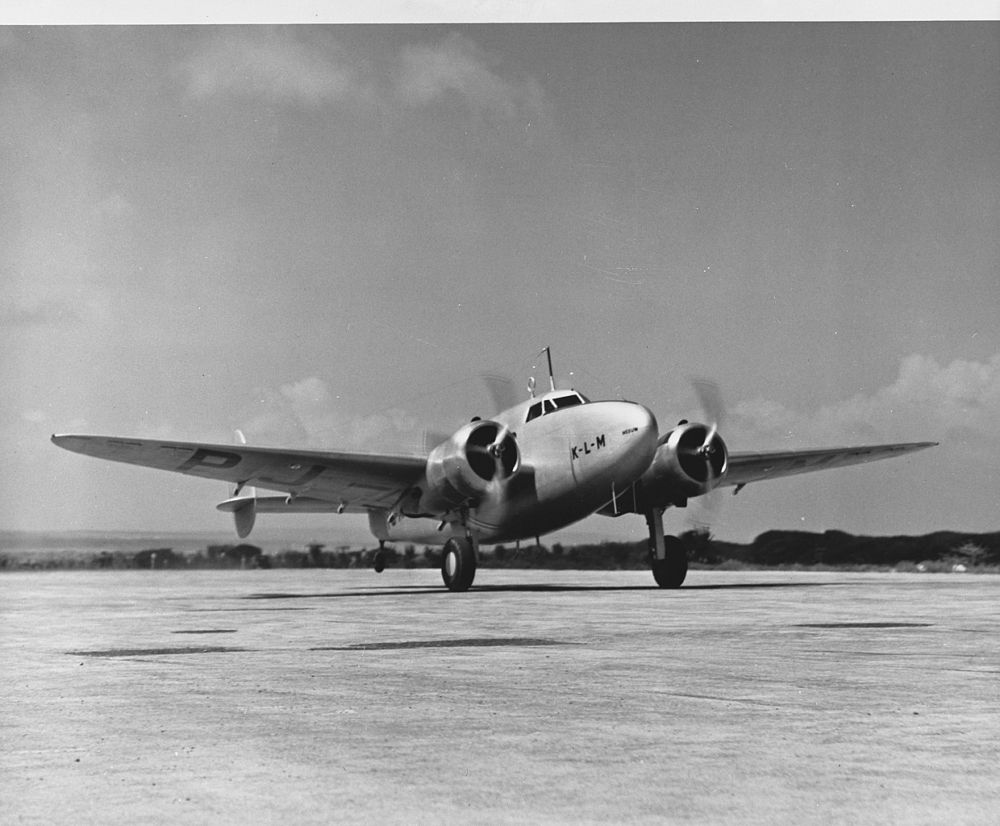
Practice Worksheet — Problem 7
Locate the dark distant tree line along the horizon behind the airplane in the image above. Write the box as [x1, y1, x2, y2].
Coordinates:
[0, 531, 1000, 571]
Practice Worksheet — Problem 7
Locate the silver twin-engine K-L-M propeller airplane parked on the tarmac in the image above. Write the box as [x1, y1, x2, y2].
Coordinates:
[52, 348, 937, 592]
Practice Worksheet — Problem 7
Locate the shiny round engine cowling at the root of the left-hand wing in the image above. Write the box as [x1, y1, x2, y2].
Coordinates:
[420, 420, 521, 512]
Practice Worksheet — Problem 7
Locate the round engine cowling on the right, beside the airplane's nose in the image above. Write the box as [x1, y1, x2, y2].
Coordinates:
[640, 424, 729, 506]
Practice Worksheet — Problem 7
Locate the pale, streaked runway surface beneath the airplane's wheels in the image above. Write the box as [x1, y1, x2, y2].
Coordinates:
[0, 570, 1000, 824]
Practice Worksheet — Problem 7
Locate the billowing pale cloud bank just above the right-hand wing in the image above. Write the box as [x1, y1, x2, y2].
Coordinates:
[731, 353, 1000, 446]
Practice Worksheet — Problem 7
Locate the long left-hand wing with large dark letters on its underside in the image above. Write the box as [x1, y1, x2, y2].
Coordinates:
[52, 435, 426, 510]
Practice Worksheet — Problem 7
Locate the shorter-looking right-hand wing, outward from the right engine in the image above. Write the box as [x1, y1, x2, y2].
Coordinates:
[722, 442, 937, 487]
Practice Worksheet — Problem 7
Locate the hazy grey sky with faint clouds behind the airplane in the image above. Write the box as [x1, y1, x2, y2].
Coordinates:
[0, 21, 1000, 540]
